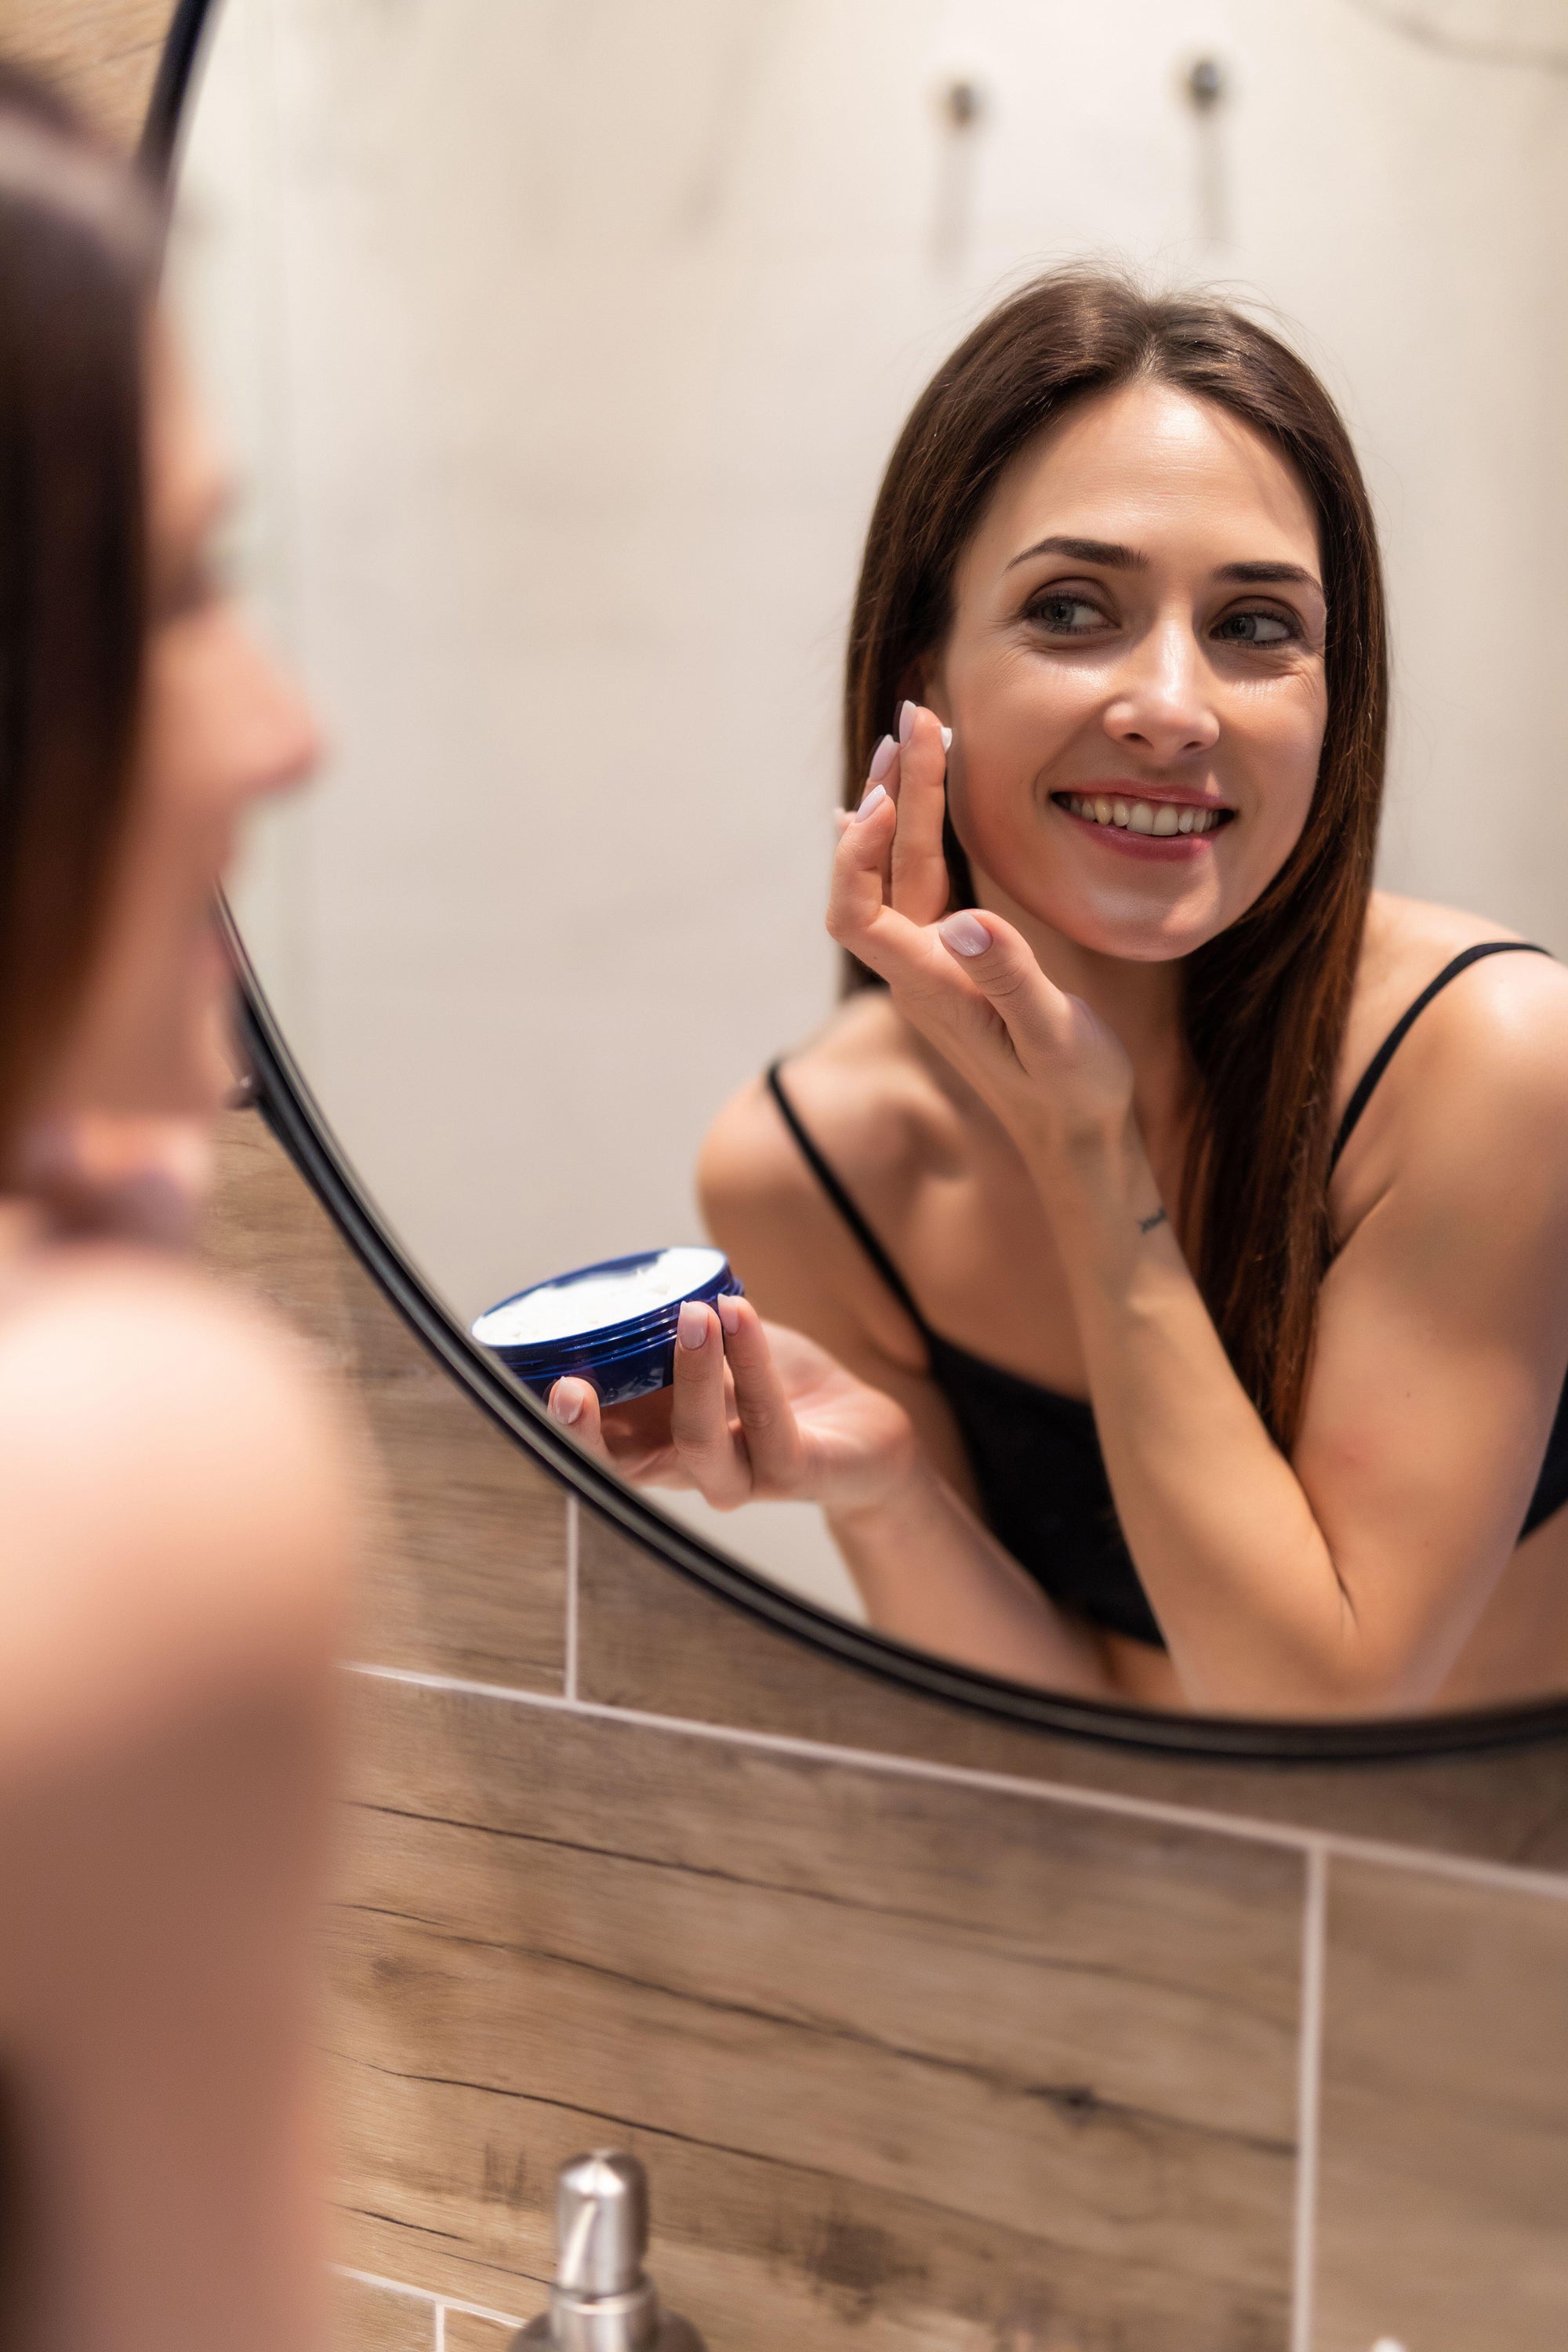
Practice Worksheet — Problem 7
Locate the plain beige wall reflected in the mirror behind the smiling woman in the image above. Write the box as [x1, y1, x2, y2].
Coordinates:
[186, 0, 1568, 1317]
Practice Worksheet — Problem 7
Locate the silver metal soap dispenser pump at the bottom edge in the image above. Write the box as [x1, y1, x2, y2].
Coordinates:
[510, 2147, 703, 2352]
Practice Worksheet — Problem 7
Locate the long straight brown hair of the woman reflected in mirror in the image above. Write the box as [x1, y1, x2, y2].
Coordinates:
[844, 270, 1387, 1446]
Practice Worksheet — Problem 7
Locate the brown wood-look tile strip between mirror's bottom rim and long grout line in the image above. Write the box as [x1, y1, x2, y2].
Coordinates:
[579, 1512, 1568, 1875]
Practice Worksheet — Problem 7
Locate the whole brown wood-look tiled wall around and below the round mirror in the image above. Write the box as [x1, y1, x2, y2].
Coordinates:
[12, 13, 1568, 2352]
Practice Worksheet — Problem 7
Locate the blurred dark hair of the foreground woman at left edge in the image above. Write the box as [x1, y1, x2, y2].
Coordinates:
[0, 61, 158, 1160]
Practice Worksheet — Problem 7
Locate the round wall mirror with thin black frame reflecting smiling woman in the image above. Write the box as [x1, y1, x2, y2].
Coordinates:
[151, 0, 1568, 1755]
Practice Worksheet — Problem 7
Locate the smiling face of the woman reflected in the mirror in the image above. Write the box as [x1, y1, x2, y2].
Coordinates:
[924, 383, 1328, 962]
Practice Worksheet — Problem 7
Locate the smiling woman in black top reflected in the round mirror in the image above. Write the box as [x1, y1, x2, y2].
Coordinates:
[557, 275, 1568, 1715]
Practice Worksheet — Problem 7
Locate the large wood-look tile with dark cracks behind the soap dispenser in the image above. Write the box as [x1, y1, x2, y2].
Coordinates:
[336, 1682, 1302, 2352]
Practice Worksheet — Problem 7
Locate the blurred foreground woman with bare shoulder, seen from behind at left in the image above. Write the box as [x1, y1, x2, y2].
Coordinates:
[0, 66, 350, 2352]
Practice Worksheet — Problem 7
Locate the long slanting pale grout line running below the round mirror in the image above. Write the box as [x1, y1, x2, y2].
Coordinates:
[346, 1661, 1568, 1903]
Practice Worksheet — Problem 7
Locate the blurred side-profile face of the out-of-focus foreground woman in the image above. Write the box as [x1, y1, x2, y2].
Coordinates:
[45, 327, 318, 1117]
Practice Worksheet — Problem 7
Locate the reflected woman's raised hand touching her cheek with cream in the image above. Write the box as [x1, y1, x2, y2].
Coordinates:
[827, 703, 1133, 1157]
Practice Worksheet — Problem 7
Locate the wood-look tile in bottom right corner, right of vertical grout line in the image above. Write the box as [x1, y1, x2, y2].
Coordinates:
[1314, 1863, 1568, 2352]
